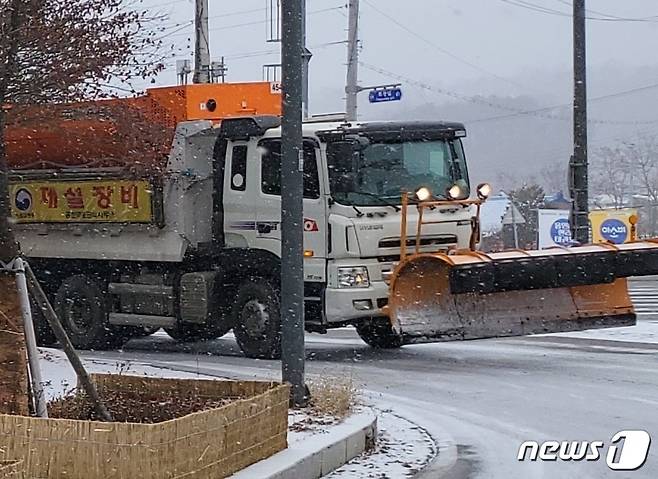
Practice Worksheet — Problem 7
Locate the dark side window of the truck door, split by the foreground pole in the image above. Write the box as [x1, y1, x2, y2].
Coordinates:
[258, 140, 320, 199]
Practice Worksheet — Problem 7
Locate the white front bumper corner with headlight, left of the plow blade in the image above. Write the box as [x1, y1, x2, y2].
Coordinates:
[325, 281, 388, 327]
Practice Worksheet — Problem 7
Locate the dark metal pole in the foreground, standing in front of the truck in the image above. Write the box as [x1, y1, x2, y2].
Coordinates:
[281, 0, 306, 405]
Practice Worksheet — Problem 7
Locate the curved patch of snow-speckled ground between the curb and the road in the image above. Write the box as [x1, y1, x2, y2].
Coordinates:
[326, 409, 437, 479]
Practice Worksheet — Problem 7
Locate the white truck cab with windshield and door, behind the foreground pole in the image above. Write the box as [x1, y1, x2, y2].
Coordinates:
[218, 120, 473, 338]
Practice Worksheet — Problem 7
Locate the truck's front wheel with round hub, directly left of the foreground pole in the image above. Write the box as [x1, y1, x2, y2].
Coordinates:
[233, 278, 281, 359]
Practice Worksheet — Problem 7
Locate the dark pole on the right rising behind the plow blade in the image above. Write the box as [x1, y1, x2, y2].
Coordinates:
[569, 0, 590, 244]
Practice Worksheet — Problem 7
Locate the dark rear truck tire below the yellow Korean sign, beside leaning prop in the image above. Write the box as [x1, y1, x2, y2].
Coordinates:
[55, 274, 126, 349]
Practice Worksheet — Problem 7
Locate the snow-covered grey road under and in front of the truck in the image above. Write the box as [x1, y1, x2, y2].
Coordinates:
[80, 320, 658, 479]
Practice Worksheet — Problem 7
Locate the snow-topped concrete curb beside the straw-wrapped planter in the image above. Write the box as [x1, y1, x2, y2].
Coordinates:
[230, 409, 377, 479]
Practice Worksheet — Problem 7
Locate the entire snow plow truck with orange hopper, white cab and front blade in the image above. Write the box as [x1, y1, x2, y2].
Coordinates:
[6, 83, 658, 358]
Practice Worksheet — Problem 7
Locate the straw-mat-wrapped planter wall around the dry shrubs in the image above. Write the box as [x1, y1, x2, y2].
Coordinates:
[0, 375, 289, 479]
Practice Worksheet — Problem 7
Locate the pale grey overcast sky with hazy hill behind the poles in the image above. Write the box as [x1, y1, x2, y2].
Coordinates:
[136, 0, 658, 184]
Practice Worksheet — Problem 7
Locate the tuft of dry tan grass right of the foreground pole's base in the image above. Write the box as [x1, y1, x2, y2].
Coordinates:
[308, 375, 359, 419]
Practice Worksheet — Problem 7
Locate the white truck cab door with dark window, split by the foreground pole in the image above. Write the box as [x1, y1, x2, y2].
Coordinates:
[256, 138, 327, 282]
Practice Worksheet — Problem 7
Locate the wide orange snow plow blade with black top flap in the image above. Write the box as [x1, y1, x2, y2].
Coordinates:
[386, 240, 658, 343]
